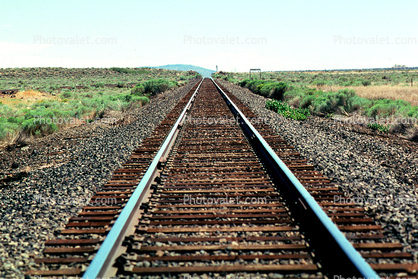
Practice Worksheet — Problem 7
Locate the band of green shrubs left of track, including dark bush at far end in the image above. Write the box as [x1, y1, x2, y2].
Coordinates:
[0, 75, 191, 141]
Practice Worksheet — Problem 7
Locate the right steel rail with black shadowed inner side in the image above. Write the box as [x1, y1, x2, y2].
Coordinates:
[211, 78, 379, 278]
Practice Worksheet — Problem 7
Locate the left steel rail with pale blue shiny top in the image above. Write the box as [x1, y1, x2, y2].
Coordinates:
[82, 79, 203, 279]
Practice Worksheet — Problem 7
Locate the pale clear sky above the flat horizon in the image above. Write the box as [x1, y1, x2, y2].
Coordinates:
[0, 0, 418, 71]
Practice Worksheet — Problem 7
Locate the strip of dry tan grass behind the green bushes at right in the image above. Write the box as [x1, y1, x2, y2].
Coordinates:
[316, 85, 418, 106]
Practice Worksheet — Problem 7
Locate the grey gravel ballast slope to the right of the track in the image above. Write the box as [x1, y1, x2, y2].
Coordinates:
[218, 80, 418, 262]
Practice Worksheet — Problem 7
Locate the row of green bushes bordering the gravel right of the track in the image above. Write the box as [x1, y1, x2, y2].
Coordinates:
[239, 79, 418, 139]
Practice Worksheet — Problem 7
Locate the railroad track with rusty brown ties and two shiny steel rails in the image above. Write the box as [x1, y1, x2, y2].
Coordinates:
[27, 79, 417, 278]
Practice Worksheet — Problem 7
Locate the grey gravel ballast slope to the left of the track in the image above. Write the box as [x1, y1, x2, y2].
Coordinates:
[0, 80, 197, 278]
